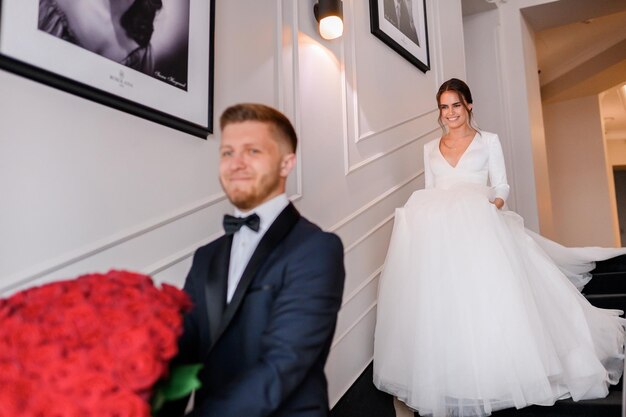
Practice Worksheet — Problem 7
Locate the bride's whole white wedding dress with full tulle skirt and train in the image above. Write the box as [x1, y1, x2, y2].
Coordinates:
[374, 132, 626, 417]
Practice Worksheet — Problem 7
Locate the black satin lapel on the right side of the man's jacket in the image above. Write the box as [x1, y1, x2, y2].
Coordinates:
[211, 203, 300, 347]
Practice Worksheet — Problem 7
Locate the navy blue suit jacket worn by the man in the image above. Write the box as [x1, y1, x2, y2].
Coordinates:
[163, 204, 345, 417]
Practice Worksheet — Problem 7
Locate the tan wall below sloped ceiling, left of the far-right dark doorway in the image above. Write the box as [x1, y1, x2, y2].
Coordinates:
[544, 96, 620, 247]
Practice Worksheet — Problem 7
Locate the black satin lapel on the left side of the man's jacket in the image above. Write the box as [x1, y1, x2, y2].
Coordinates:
[204, 235, 233, 344]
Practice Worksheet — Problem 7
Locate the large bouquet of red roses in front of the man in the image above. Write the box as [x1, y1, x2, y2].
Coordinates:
[0, 271, 197, 417]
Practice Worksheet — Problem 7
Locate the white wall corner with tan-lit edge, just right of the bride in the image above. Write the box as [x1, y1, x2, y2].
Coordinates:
[464, 0, 554, 237]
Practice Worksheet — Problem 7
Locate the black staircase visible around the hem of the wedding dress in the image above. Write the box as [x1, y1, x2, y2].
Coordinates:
[330, 255, 626, 417]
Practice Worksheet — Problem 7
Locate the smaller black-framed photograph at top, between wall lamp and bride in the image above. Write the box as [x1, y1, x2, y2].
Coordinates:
[370, 0, 430, 72]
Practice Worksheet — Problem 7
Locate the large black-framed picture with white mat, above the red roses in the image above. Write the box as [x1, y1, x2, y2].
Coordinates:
[0, 0, 215, 139]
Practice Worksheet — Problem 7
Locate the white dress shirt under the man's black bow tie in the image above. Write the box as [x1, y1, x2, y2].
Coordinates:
[226, 194, 289, 303]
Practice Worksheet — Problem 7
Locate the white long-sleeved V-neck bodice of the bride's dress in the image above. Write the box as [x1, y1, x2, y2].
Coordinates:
[424, 132, 509, 200]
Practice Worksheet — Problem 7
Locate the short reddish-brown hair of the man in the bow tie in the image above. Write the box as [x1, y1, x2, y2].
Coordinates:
[220, 103, 298, 153]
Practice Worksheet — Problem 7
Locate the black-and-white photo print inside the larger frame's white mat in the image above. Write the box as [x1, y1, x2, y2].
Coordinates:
[38, 0, 190, 91]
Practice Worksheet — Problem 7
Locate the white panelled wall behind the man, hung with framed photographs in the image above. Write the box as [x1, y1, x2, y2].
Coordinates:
[0, 0, 465, 404]
